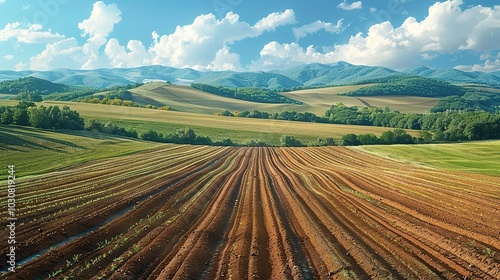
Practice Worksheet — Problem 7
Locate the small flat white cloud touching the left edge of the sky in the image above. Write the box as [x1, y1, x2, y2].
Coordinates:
[0, 22, 64, 43]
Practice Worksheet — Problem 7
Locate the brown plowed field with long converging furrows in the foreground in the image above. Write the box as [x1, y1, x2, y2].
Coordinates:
[0, 145, 500, 279]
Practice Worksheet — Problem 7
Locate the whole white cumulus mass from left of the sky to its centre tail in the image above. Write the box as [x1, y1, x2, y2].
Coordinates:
[30, 6, 296, 70]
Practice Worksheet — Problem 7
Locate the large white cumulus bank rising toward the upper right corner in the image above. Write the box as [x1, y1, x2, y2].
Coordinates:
[254, 0, 500, 69]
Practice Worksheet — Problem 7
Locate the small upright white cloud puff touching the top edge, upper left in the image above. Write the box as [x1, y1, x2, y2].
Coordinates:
[78, 1, 122, 37]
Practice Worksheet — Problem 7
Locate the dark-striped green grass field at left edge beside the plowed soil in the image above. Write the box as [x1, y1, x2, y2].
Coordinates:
[0, 125, 160, 176]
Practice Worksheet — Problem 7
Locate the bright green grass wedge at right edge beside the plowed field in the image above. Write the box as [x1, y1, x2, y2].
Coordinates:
[358, 141, 500, 176]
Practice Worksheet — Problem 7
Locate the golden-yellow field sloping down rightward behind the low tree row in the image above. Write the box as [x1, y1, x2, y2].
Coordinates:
[20, 101, 418, 139]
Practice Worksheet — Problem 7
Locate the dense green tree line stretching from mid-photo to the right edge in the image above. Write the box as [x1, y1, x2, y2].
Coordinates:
[218, 103, 500, 141]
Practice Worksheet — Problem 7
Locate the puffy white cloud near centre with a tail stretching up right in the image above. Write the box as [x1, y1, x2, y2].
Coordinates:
[149, 10, 295, 69]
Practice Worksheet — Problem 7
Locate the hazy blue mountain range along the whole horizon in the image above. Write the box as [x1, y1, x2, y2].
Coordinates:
[0, 62, 500, 89]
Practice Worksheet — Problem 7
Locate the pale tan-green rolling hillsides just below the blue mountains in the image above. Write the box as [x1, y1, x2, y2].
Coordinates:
[130, 83, 438, 116]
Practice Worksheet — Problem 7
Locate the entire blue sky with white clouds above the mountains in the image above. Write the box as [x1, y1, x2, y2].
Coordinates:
[0, 0, 500, 72]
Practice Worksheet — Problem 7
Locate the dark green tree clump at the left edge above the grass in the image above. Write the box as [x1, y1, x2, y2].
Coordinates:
[0, 101, 85, 130]
